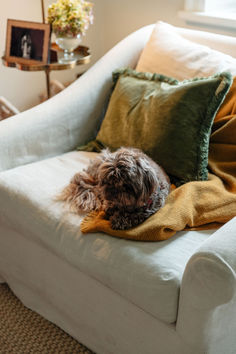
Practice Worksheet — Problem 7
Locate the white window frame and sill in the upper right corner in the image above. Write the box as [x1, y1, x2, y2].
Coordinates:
[178, 0, 236, 31]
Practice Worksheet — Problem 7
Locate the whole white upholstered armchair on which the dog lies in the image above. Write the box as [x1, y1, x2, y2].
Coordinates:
[0, 25, 236, 354]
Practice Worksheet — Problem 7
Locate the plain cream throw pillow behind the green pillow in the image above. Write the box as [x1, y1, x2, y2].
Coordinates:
[136, 22, 236, 80]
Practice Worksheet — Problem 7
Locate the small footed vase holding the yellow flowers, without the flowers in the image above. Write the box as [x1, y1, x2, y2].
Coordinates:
[56, 34, 81, 62]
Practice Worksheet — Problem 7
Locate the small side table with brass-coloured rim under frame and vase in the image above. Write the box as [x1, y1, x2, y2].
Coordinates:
[2, 43, 91, 98]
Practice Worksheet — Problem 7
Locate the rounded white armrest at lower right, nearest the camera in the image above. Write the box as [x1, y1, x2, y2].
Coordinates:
[176, 217, 236, 354]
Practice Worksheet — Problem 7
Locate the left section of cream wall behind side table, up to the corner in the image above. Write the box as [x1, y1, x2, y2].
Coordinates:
[0, 0, 104, 111]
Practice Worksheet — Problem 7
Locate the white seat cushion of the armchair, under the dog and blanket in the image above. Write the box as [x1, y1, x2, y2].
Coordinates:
[0, 152, 213, 323]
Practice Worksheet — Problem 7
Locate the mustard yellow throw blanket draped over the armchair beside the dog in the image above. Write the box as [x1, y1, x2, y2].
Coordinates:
[81, 79, 236, 241]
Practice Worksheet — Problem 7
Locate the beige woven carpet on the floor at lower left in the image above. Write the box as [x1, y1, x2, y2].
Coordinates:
[0, 284, 92, 354]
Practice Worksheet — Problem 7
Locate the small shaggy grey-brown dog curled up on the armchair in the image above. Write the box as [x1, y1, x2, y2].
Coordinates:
[60, 148, 170, 230]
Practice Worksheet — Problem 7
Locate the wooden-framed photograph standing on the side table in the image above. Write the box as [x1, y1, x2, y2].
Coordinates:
[5, 19, 50, 64]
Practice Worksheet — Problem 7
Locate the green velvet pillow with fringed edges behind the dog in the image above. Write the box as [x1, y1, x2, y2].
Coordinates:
[78, 69, 232, 184]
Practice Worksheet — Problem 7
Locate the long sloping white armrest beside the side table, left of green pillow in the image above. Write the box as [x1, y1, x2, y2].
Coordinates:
[0, 25, 153, 171]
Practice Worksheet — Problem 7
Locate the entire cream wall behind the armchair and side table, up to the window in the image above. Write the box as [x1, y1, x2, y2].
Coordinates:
[0, 0, 236, 110]
